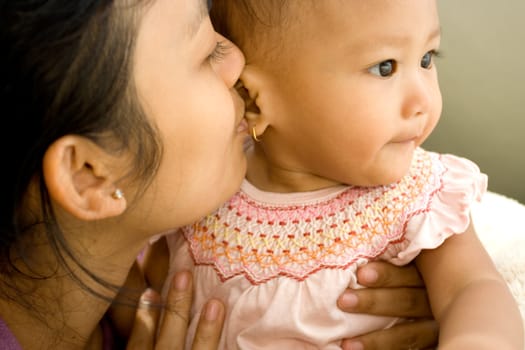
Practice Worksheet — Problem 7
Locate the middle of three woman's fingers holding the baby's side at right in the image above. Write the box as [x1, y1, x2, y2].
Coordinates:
[337, 288, 433, 318]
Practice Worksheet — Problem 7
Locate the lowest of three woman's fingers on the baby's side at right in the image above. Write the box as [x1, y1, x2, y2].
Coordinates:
[342, 320, 439, 350]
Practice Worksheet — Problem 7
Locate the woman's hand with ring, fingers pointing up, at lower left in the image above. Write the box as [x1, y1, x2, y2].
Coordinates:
[127, 272, 224, 350]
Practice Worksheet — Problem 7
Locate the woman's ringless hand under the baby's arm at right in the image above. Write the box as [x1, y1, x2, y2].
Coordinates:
[338, 262, 439, 350]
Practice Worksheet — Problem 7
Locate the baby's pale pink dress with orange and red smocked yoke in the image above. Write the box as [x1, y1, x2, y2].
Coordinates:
[164, 148, 487, 350]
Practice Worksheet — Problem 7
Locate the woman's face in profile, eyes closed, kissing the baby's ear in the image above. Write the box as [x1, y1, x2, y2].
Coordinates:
[134, 0, 247, 232]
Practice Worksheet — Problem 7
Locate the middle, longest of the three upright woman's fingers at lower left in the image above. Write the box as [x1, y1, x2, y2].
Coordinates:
[157, 271, 192, 350]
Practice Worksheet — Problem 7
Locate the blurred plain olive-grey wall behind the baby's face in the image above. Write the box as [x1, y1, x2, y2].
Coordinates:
[423, 0, 525, 203]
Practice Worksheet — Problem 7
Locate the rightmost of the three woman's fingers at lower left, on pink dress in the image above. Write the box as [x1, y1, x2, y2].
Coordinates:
[192, 299, 224, 350]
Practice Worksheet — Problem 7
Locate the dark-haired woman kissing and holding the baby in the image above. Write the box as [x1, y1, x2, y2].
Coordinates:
[0, 0, 435, 349]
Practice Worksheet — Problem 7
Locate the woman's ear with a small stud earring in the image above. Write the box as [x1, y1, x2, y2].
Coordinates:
[43, 135, 126, 220]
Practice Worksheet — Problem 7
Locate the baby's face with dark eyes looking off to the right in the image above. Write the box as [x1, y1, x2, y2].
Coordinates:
[246, 0, 442, 190]
